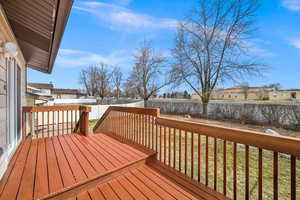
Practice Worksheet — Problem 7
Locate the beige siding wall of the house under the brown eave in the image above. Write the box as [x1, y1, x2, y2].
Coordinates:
[0, 4, 26, 178]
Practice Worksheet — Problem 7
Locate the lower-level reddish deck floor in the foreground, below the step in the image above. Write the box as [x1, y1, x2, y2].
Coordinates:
[77, 165, 204, 200]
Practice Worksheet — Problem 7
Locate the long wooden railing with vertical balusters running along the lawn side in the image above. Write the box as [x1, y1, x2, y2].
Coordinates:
[94, 107, 300, 200]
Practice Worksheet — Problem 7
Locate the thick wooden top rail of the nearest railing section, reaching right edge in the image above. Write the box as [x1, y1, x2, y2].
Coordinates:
[156, 117, 300, 157]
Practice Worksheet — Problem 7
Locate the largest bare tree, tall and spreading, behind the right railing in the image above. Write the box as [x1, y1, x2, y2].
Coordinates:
[171, 0, 261, 115]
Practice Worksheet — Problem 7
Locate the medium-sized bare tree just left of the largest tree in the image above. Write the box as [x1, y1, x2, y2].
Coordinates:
[127, 40, 170, 106]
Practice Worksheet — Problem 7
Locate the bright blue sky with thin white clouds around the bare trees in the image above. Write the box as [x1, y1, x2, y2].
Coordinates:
[28, 0, 300, 92]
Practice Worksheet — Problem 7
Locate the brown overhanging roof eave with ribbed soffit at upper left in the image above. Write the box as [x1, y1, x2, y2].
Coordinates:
[0, 0, 73, 73]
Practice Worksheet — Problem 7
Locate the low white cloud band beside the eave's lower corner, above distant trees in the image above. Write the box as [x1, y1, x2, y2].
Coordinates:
[57, 49, 132, 67]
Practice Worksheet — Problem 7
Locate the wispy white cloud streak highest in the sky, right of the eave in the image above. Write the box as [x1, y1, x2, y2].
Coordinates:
[74, 1, 177, 30]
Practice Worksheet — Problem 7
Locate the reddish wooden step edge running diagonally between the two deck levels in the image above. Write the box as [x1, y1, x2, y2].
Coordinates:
[38, 154, 155, 200]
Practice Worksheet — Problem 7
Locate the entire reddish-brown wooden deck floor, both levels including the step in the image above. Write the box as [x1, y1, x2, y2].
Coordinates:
[0, 134, 224, 200]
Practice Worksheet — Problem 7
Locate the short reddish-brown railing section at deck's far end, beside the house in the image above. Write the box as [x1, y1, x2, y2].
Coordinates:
[22, 105, 91, 139]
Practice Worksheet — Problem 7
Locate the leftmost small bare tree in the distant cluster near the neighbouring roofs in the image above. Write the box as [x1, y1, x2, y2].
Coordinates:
[79, 65, 98, 96]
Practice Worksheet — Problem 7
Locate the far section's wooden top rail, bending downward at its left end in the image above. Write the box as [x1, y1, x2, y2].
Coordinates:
[93, 106, 160, 133]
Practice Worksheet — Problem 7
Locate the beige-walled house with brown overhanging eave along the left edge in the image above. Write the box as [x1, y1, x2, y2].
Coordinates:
[0, 0, 73, 177]
